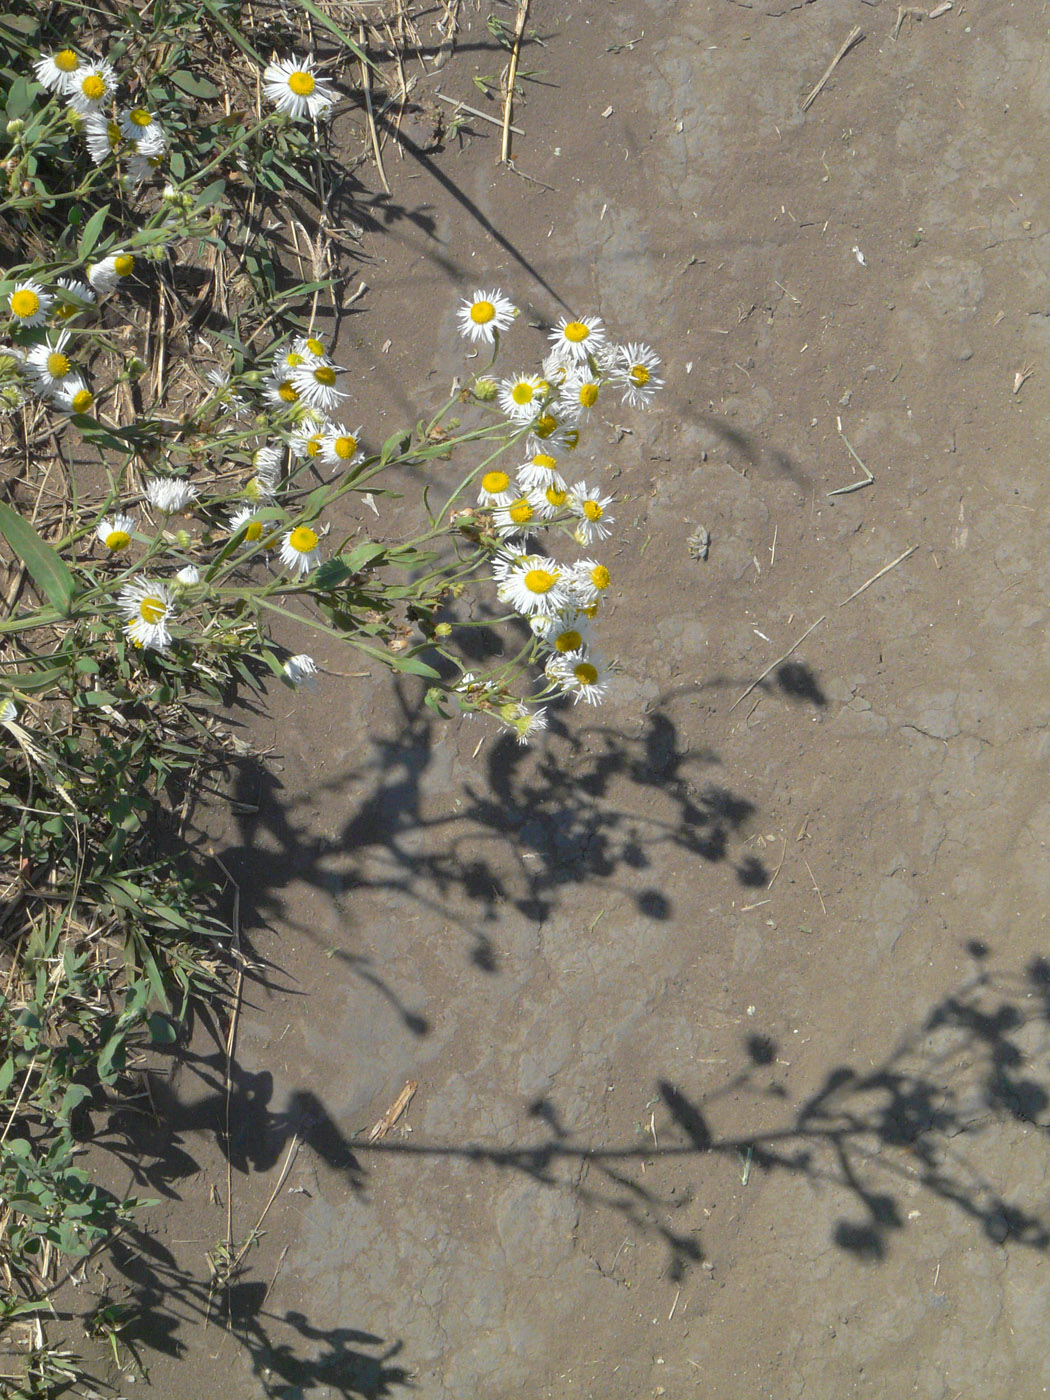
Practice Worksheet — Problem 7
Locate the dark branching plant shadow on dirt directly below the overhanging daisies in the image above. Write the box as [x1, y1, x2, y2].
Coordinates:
[215, 683, 769, 980]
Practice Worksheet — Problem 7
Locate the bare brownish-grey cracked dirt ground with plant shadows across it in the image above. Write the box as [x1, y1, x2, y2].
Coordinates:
[84, 0, 1050, 1400]
